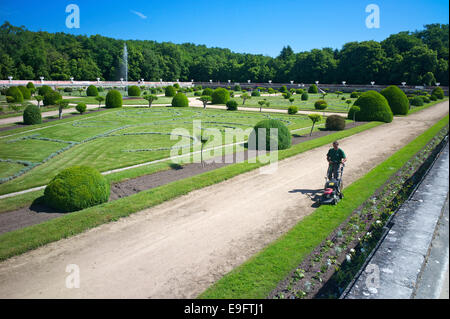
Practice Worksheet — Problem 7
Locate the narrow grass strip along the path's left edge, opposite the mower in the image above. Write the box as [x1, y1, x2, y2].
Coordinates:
[0, 122, 383, 261]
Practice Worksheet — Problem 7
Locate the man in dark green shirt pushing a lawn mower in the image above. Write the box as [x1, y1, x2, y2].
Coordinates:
[319, 141, 347, 205]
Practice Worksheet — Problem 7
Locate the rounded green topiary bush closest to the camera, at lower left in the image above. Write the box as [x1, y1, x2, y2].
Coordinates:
[44, 166, 110, 212]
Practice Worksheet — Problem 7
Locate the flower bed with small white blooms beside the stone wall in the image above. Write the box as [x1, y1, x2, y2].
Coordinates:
[268, 125, 448, 299]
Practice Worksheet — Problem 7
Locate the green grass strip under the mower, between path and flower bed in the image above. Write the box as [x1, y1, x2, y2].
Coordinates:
[198, 115, 448, 299]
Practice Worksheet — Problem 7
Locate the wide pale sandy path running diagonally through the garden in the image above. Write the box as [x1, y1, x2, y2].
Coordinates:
[0, 101, 449, 298]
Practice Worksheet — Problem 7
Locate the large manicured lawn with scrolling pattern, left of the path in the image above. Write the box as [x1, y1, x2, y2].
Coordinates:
[0, 107, 323, 194]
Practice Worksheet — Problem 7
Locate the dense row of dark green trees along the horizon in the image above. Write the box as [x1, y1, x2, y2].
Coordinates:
[0, 22, 449, 85]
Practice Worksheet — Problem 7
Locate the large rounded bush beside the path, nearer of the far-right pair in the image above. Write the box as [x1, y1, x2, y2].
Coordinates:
[354, 90, 393, 123]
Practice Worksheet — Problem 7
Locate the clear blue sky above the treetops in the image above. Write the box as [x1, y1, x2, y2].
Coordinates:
[0, 0, 449, 56]
